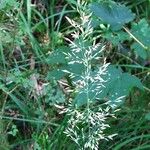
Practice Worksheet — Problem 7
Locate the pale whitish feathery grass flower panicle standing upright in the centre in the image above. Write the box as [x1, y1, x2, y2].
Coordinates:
[63, 0, 117, 150]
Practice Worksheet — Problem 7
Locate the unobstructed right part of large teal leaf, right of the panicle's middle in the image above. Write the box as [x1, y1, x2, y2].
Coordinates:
[99, 66, 143, 105]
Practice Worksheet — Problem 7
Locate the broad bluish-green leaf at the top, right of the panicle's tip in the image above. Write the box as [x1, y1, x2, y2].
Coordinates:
[90, 2, 134, 30]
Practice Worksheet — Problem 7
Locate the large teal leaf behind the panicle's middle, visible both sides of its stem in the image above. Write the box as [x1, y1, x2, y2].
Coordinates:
[75, 63, 143, 107]
